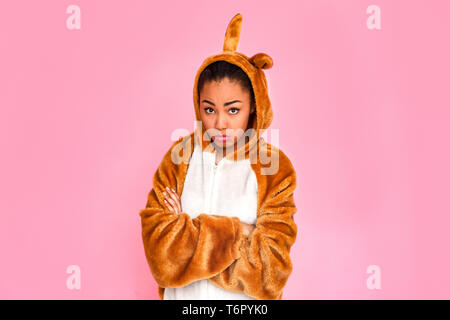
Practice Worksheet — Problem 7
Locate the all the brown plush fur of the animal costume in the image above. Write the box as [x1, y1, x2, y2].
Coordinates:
[139, 14, 297, 300]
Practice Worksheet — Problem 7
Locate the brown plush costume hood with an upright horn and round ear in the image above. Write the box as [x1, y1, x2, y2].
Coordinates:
[194, 13, 273, 161]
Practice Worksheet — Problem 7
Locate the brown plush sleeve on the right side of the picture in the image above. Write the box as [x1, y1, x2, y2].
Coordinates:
[209, 149, 297, 300]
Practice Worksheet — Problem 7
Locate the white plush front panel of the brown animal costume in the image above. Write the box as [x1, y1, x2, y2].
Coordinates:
[164, 145, 258, 300]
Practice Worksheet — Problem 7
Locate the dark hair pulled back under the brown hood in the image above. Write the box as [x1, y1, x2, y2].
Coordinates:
[197, 60, 255, 106]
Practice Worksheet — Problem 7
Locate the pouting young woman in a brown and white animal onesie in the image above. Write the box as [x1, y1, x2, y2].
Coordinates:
[140, 14, 297, 300]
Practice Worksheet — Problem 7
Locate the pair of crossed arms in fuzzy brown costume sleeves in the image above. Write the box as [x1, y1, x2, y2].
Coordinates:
[140, 140, 297, 299]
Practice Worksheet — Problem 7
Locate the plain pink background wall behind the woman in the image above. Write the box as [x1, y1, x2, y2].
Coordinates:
[0, 0, 450, 299]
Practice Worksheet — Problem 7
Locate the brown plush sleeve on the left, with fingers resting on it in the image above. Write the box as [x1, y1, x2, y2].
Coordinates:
[139, 139, 244, 288]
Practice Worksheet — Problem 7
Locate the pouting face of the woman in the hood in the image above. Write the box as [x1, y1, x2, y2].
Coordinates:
[200, 78, 255, 148]
